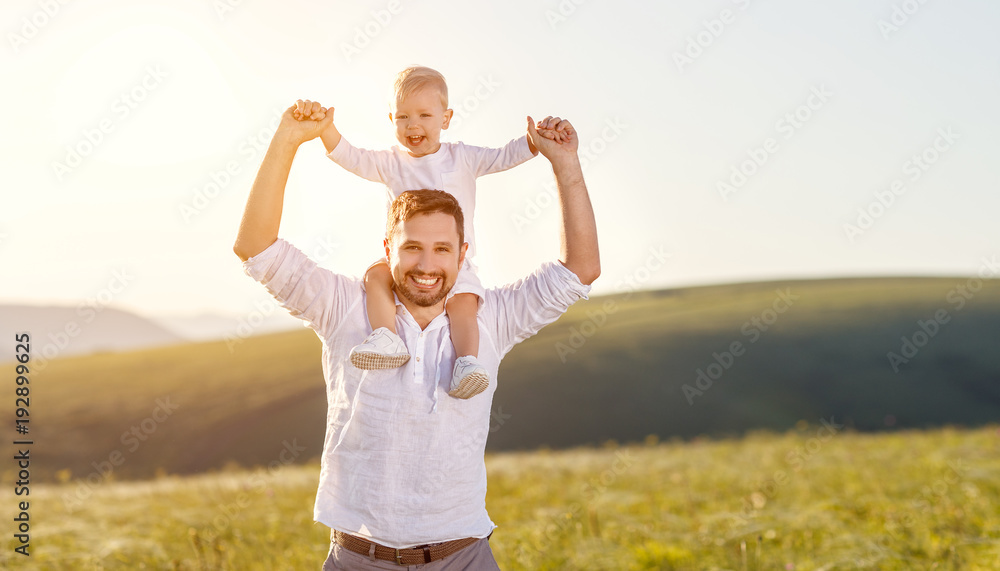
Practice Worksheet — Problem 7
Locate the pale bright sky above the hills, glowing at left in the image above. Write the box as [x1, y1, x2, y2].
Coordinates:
[0, 0, 1000, 328]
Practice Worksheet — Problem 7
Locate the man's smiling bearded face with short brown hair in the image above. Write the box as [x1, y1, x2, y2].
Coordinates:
[386, 212, 468, 309]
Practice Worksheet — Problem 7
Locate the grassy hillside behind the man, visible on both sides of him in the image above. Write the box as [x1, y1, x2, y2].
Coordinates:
[0, 278, 1000, 481]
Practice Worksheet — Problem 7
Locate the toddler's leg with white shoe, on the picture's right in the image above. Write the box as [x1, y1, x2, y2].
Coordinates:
[445, 293, 490, 399]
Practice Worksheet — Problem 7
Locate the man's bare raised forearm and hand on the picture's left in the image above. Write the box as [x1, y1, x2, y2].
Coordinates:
[233, 101, 333, 261]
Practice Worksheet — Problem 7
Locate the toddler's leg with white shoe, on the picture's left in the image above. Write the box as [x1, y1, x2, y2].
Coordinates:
[351, 261, 410, 369]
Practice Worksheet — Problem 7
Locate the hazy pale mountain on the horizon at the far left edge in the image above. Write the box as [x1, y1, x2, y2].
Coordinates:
[0, 305, 184, 362]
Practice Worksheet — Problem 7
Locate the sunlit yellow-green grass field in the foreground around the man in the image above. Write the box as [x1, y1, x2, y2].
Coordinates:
[0, 421, 1000, 571]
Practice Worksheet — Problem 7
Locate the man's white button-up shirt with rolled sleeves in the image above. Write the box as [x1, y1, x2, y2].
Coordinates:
[243, 238, 590, 548]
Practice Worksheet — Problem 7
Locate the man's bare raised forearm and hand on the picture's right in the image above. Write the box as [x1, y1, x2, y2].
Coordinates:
[528, 117, 601, 285]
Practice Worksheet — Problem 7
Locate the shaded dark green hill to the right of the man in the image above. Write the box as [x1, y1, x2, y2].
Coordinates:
[490, 278, 1000, 449]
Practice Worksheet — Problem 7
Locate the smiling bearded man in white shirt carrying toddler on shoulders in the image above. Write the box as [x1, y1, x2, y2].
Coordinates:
[233, 102, 600, 571]
